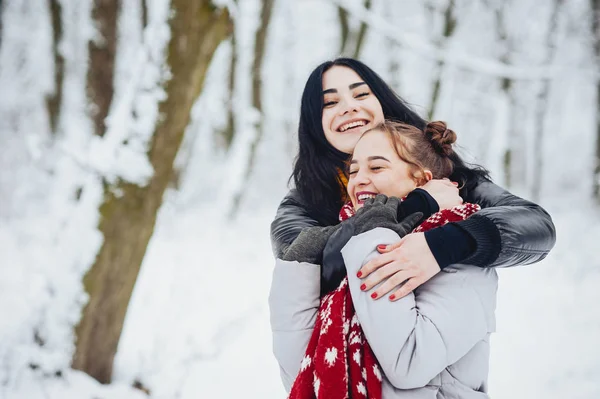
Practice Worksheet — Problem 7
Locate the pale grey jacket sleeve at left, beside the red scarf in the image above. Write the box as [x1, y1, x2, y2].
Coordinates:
[269, 259, 321, 392]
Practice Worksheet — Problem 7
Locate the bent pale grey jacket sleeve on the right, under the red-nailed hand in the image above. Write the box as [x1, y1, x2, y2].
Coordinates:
[342, 228, 497, 389]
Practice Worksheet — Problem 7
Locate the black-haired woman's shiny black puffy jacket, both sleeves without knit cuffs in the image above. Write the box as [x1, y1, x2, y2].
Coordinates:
[271, 179, 556, 267]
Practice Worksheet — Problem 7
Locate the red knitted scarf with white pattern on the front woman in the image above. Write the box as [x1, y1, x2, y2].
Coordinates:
[289, 203, 481, 399]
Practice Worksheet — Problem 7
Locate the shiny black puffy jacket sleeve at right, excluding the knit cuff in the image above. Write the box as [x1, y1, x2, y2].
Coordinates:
[456, 179, 556, 267]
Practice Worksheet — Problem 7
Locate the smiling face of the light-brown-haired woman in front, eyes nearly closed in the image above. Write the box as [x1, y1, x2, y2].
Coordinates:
[348, 130, 417, 209]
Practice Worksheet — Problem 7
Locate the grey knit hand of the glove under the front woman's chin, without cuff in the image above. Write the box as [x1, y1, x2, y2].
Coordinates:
[352, 194, 423, 237]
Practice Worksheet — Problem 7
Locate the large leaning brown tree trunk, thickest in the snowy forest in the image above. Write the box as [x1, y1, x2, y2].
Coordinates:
[73, 0, 231, 383]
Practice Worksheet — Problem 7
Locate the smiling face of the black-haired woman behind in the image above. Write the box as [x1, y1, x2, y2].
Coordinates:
[322, 65, 384, 154]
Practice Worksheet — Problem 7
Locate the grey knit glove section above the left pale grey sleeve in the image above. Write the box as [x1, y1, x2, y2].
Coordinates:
[281, 224, 340, 265]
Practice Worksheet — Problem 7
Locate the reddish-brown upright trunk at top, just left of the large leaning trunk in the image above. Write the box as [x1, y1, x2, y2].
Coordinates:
[87, 0, 119, 136]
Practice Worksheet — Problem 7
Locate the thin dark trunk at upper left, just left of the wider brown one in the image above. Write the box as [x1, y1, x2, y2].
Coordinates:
[46, 0, 65, 134]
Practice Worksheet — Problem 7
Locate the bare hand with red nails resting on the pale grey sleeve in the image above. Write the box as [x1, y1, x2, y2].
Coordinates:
[357, 233, 440, 301]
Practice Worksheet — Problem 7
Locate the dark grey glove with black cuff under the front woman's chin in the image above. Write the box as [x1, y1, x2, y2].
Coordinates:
[321, 195, 423, 296]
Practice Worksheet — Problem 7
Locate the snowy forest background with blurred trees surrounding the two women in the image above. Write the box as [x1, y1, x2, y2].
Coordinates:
[0, 0, 600, 399]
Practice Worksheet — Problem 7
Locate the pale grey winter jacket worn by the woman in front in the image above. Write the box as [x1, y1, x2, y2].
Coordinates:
[269, 228, 497, 399]
